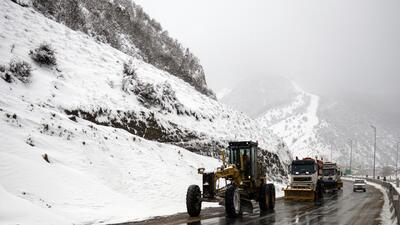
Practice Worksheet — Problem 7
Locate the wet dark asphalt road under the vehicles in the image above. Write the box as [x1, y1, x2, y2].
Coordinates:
[114, 181, 384, 225]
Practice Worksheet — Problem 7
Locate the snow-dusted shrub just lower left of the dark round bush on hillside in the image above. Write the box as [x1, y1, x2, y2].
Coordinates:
[4, 60, 32, 83]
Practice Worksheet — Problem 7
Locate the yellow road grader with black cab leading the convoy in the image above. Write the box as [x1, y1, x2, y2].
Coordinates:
[186, 141, 275, 218]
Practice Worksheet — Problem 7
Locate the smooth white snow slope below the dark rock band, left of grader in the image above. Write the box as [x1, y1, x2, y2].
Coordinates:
[0, 104, 220, 224]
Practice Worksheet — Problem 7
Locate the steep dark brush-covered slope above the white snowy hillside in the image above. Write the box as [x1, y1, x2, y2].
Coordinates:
[31, 0, 215, 98]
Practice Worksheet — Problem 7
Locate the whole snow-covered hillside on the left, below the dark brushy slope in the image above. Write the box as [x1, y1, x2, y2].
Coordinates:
[0, 0, 289, 225]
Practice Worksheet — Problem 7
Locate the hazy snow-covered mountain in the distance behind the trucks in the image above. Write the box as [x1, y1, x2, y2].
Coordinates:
[222, 77, 396, 174]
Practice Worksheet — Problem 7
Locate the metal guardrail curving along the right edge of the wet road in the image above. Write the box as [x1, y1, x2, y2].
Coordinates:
[346, 176, 400, 225]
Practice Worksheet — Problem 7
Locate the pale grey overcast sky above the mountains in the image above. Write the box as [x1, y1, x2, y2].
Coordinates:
[135, 0, 400, 125]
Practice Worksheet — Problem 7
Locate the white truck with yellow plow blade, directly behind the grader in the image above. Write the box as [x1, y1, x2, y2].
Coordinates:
[284, 158, 323, 201]
